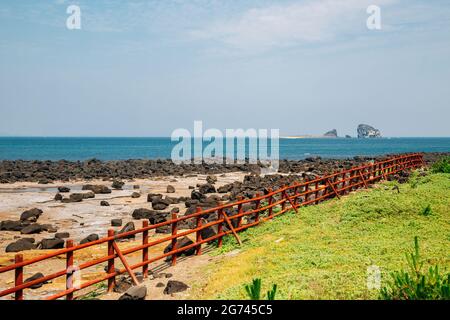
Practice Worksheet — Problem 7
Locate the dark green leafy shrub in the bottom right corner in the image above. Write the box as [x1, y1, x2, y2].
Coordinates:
[380, 237, 450, 300]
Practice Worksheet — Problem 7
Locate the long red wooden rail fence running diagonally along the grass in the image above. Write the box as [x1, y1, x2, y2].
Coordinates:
[0, 153, 424, 300]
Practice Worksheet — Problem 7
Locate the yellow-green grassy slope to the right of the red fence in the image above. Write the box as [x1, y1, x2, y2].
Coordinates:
[192, 174, 450, 299]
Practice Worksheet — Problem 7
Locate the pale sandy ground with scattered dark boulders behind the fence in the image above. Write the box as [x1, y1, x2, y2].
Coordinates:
[0, 172, 245, 299]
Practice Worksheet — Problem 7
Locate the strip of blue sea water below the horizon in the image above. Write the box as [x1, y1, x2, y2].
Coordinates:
[0, 137, 450, 161]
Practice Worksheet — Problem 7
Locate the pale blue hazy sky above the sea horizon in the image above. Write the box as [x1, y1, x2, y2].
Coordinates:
[0, 0, 450, 137]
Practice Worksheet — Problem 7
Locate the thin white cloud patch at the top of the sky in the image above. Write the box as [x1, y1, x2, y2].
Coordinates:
[191, 0, 395, 50]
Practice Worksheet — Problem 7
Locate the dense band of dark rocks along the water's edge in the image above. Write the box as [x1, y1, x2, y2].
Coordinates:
[0, 153, 441, 184]
